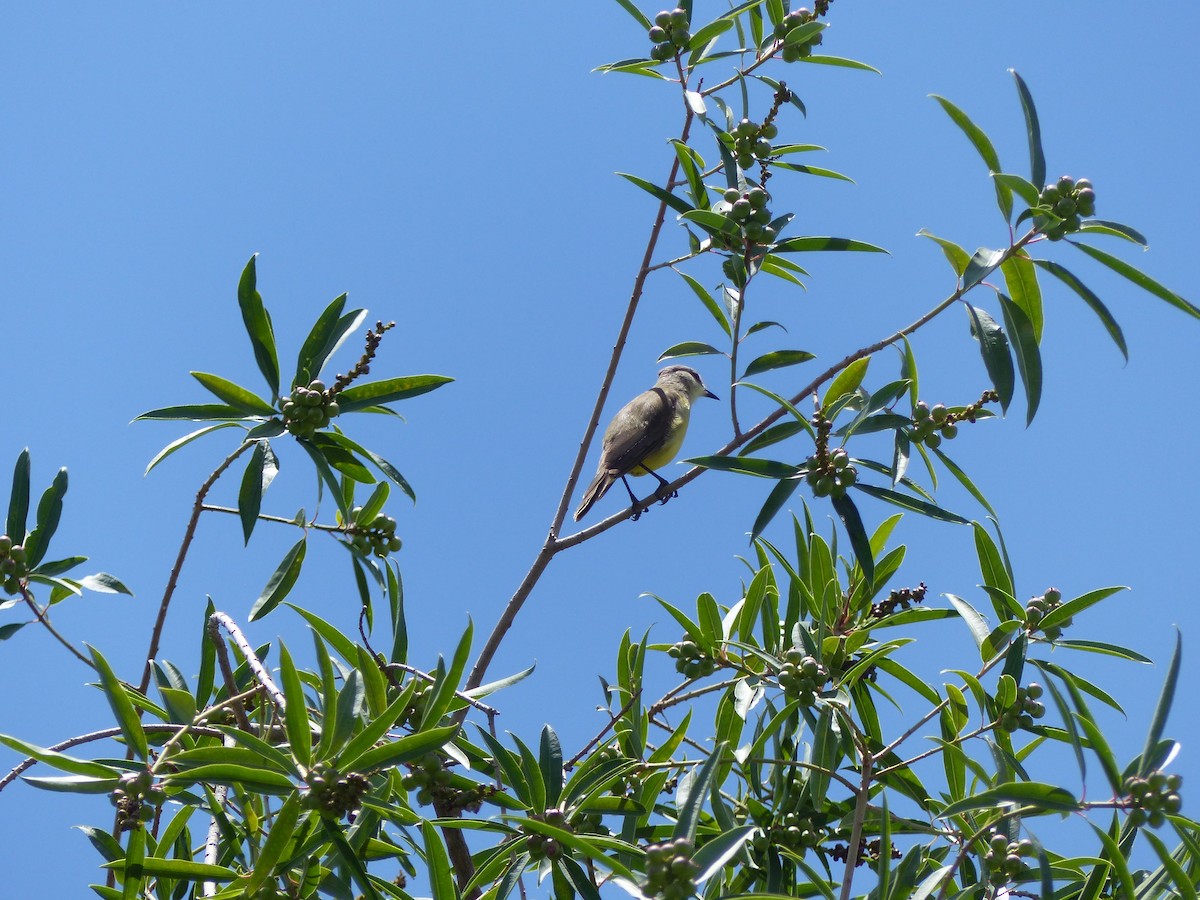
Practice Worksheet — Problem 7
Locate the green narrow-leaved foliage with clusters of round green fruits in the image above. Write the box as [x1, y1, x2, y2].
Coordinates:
[0, 0, 1200, 900]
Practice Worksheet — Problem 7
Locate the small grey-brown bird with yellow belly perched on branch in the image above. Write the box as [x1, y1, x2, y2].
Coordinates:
[575, 366, 716, 522]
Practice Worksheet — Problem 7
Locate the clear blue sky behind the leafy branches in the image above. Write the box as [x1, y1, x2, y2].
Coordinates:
[0, 0, 1200, 898]
